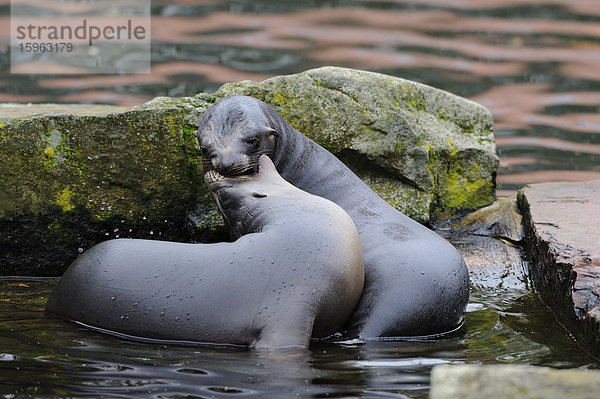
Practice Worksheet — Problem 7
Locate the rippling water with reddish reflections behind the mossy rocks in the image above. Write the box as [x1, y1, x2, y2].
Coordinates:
[0, 0, 600, 195]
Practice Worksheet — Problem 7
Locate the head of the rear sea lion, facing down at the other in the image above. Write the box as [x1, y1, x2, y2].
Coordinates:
[196, 96, 279, 176]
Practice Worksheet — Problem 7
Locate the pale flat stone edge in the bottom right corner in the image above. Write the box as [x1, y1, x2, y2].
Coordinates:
[429, 364, 600, 399]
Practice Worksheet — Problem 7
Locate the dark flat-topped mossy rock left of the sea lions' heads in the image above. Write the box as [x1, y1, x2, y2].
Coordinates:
[0, 99, 225, 276]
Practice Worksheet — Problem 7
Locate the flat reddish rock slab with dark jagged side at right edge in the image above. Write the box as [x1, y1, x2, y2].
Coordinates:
[518, 180, 600, 357]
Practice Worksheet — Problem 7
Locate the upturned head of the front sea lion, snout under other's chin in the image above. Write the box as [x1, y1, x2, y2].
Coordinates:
[204, 155, 288, 239]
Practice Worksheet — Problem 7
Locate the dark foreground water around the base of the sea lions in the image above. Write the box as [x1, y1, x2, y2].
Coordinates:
[0, 281, 600, 399]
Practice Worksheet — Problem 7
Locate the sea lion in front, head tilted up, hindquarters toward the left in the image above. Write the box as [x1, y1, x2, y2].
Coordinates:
[46, 156, 364, 348]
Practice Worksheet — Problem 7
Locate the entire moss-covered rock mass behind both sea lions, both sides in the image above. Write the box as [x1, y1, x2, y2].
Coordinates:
[0, 68, 498, 276]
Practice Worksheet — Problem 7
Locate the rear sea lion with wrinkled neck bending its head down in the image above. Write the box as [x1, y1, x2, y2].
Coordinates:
[197, 96, 469, 338]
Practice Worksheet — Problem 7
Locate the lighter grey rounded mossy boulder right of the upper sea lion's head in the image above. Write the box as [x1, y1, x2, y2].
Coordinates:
[215, 67, 498, 222]
